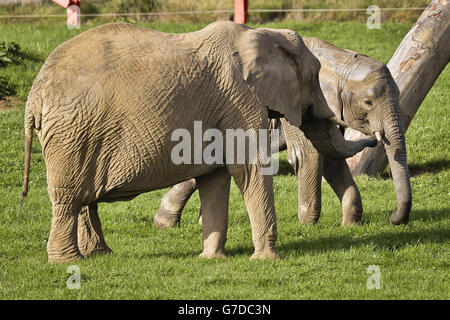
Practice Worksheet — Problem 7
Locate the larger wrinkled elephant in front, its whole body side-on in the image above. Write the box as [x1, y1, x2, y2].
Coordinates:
[22, 22, 376, 262]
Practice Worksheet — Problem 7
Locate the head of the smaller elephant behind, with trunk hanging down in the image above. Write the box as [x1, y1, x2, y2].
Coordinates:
[305, 38, 412, 224]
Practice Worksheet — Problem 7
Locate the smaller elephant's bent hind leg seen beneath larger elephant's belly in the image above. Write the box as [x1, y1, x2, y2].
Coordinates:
[153, 179, 197, 229]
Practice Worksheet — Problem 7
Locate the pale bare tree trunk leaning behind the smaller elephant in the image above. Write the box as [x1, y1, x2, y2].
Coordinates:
[345, 0, 450, 176]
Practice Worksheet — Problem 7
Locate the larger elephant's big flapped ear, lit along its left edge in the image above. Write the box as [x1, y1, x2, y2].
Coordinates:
[238, 29, 302, 126]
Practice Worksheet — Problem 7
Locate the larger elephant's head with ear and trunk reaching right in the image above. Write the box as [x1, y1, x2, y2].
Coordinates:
[229, 26, 376, 158]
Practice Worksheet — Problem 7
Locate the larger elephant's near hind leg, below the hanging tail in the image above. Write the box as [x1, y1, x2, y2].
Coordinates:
[47, 188, 83, 262]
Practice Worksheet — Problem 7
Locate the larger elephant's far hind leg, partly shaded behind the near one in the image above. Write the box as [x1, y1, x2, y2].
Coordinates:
[78, 203, 112, 257]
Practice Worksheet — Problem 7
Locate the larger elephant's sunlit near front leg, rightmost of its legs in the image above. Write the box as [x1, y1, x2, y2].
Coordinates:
[227, 164, 280, 259]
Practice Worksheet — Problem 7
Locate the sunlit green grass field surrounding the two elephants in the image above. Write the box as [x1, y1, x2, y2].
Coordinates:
[0, 22, 450, 299]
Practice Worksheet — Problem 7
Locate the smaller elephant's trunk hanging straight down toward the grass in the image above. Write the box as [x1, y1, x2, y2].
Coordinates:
[383, 109, 412, 224]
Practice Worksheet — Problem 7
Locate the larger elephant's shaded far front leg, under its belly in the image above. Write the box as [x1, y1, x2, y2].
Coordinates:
[196, 167, 231, 258]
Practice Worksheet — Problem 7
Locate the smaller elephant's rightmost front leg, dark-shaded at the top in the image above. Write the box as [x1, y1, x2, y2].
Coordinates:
[323, 158, 363, 226]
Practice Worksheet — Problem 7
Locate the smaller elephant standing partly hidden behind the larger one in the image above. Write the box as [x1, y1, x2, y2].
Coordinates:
[154, 38, 412, 228]
